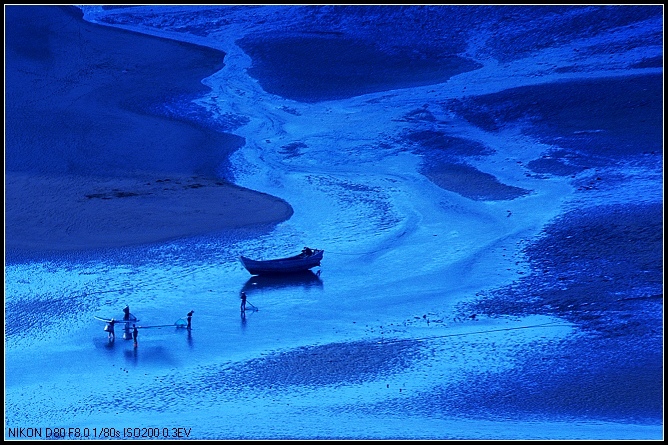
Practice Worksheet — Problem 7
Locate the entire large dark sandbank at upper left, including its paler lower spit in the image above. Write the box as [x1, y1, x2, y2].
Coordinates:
[5, 6, 292, 252]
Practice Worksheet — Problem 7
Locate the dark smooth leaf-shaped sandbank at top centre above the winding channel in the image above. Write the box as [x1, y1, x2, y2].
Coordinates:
[237, 34, 481, 103]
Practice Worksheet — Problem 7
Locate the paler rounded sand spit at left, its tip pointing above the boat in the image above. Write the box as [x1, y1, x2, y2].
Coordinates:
[5, 173, 292, 252]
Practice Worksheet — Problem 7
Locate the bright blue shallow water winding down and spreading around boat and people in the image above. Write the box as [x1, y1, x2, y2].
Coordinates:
[5, 8, 662, 439]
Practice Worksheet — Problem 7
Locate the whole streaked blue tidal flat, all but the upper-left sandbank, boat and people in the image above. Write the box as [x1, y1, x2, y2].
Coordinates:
[5, 6, 663, 440]
